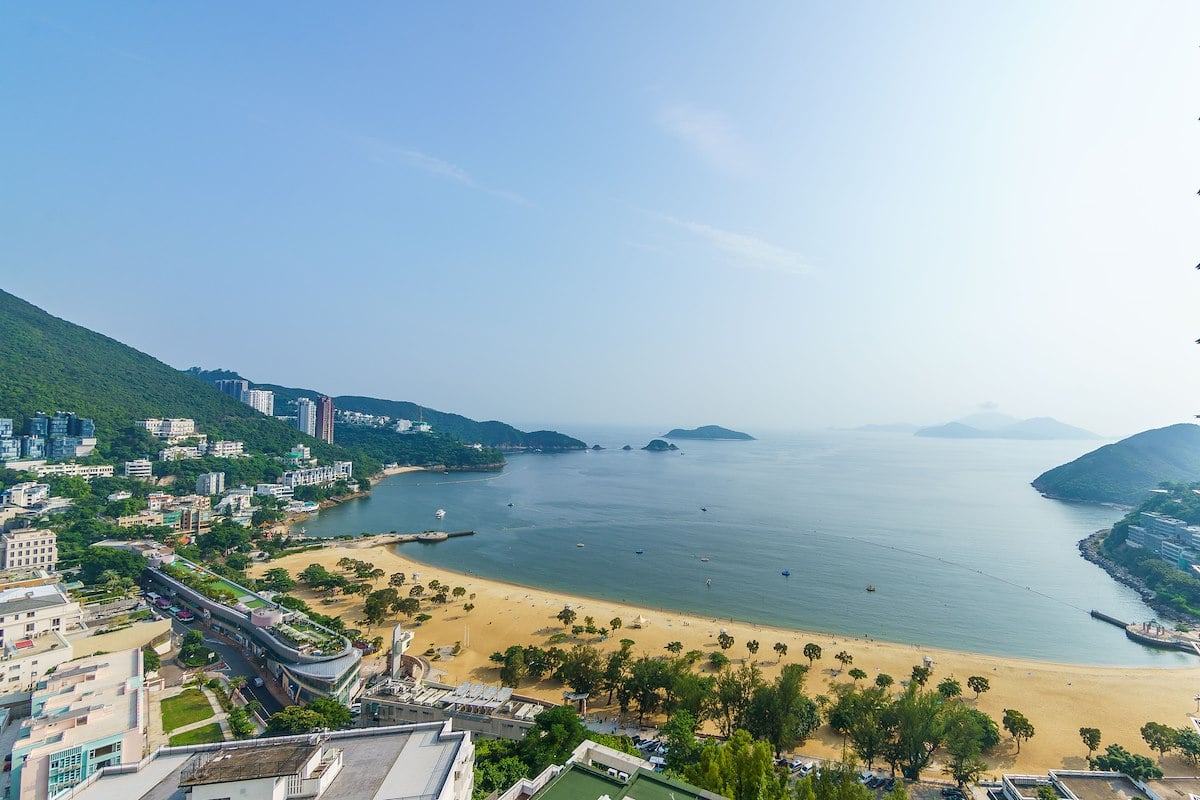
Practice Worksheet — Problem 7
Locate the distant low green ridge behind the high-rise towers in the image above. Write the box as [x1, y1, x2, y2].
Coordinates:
[187, 367, 587, 452]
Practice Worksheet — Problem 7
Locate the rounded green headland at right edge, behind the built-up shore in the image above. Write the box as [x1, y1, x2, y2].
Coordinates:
[1033, 423, 1200, 505]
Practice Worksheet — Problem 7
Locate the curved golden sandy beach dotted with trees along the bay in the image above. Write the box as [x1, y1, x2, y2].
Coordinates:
[250, 540, 1200, 777]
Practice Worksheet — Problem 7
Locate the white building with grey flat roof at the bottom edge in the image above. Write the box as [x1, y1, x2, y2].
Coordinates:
[59, 723, 472, 800]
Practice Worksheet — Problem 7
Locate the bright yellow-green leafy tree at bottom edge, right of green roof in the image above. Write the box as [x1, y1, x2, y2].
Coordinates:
[684, 730, 787, 800]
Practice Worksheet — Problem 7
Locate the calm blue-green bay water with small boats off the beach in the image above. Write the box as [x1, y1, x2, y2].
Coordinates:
[295, 429, 1195, 666]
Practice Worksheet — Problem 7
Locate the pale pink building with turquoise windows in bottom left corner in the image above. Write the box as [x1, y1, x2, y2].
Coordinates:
[10, 648, 148, 800]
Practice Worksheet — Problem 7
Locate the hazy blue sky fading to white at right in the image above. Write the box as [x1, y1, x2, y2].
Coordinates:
[0, 0, 1200, 434]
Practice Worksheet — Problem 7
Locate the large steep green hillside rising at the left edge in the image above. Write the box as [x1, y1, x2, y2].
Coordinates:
[0, 290, 379, 475]
